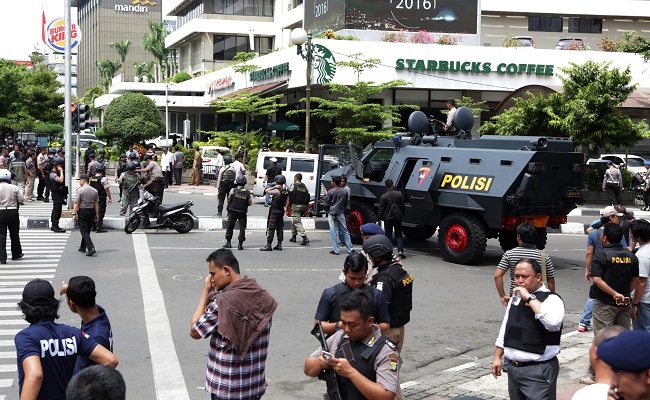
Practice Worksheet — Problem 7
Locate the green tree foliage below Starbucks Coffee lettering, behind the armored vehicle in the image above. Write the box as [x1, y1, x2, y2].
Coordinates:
[480, 61, 648, 160]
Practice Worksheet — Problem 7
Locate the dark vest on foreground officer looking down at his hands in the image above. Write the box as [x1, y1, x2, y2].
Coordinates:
[334, 336, 394, 400]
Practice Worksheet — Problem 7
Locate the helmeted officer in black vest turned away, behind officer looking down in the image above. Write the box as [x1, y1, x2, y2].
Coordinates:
[363, 235, 413, 351]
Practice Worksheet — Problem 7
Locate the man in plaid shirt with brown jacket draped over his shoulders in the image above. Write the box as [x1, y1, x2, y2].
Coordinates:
[190, 249, 278, 400]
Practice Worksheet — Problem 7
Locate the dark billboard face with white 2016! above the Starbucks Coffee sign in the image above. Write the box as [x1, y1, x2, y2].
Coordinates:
[344, 0, 479, 34]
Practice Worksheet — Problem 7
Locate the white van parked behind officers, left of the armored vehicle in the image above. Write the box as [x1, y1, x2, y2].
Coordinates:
[253, 151, 338, 197]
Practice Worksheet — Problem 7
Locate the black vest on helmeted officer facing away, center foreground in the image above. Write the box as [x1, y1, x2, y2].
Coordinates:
[372, 261, 413, 327]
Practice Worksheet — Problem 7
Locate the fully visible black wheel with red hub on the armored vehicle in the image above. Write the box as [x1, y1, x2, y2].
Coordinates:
[438, 213, 487, 264]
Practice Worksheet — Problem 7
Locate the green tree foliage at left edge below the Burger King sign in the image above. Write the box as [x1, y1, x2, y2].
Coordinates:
[0, 59, 63, 132]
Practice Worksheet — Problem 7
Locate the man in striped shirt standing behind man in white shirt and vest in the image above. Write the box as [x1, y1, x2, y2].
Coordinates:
[494, 222, 555, 307]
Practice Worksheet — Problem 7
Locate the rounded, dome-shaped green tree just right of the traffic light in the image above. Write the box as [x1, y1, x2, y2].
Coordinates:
[103, 92, 165, 147]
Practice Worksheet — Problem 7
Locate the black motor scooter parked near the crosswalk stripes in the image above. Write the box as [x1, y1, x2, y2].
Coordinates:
[124, 190, 194, 233]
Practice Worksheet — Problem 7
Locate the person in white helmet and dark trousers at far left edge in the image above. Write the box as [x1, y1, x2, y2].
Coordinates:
[0, 169, 25, 264]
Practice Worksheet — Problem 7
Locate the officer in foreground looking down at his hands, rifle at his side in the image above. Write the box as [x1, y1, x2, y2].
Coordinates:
[303, 290, 402, 400]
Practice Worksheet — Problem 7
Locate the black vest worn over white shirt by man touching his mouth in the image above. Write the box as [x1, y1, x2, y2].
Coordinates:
[503, 292, 562, 354]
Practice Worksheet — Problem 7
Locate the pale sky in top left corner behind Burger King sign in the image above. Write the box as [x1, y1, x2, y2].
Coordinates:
[0, 0, 74, 60]
